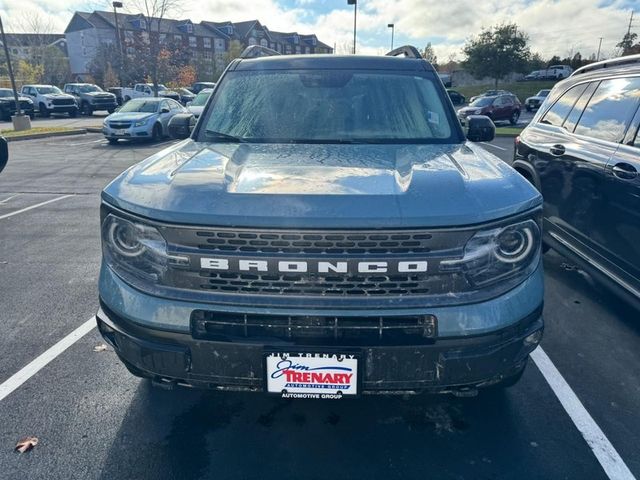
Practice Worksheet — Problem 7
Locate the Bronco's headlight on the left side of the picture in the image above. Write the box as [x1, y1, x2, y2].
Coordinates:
[102, 214, 189, 283]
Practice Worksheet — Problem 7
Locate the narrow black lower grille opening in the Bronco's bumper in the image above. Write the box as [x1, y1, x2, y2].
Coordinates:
[191, 310, 437, 345]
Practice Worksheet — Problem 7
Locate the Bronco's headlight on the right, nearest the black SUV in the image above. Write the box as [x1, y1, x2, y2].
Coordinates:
[440, 219, 541, 288]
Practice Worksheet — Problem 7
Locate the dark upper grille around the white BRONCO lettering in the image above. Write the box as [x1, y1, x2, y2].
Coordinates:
[160, 227, 473, 298]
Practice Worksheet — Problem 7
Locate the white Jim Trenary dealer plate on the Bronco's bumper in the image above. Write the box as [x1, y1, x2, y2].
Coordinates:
[266, 352, 359, 399]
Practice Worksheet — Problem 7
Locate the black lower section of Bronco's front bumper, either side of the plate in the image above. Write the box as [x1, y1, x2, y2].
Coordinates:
[97, 305, 543, 394]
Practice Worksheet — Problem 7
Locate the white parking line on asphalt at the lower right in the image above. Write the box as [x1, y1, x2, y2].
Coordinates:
[531, 347, 635, 480]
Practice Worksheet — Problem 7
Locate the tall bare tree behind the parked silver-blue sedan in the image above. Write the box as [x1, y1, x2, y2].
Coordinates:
[130, 0, 182, 96]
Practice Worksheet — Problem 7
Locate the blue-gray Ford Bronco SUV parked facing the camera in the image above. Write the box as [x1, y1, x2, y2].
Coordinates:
[97, 47, 543, 399]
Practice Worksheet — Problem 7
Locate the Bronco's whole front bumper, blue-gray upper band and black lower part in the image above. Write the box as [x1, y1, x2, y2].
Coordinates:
[97, 258, 543, 394]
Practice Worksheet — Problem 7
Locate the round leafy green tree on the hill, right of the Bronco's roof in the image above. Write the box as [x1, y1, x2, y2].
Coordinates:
[463, 23, 531, 88]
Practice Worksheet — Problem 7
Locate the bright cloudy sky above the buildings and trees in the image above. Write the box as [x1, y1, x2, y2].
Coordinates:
[0, 0, 640, 61]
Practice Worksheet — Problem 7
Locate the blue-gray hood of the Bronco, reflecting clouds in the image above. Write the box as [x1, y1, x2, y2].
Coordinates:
[102, 139, 542, 228]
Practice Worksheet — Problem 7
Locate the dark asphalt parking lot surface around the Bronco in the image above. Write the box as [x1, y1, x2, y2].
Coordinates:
[0, 135, 640, 479]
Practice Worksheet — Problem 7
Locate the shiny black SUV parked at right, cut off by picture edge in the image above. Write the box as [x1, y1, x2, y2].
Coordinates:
[513, 55, 640, 306]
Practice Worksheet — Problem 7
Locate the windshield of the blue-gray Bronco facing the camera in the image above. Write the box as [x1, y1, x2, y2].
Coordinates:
[199, 70, 457, 143]
